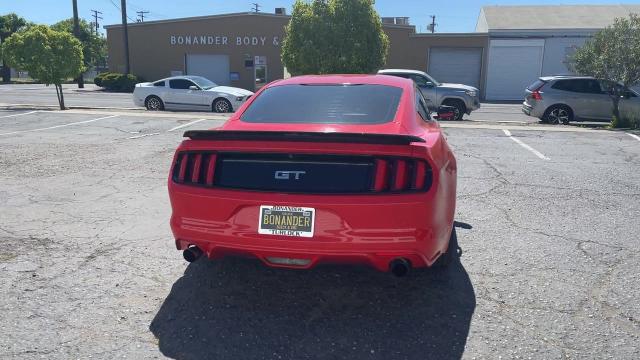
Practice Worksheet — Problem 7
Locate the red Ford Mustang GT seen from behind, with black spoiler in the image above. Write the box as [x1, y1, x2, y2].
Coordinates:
[169, 75, 456, 276]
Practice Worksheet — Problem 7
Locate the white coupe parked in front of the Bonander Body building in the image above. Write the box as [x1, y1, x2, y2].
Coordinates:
[133, 76, 253, 113]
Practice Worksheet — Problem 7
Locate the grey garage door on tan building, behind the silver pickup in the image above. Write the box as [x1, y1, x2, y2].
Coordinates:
[427, 48, 482, 88]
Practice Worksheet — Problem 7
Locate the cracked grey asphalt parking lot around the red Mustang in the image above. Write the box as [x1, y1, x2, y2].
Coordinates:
[0, 110, 640, 359]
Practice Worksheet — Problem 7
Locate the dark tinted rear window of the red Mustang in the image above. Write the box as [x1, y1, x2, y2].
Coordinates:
[241, 84, 402, 124]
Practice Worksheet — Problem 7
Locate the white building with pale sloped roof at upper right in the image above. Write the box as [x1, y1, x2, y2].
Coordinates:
[476, 5, 640, 100]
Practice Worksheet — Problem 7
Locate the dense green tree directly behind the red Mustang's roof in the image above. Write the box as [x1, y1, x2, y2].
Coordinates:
[282, 0, 389, 75]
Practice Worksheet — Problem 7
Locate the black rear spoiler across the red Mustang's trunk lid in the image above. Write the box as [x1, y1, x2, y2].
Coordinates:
[184, 130, 425, 145]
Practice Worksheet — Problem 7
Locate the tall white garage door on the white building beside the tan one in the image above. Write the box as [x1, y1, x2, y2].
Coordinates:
[486, 40, 544, 100]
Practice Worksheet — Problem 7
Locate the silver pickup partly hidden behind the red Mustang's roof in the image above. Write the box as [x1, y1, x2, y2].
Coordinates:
[378, 69, 480, 120]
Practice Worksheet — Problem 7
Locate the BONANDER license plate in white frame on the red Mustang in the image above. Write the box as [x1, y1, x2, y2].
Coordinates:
[258, 205, 316, 237]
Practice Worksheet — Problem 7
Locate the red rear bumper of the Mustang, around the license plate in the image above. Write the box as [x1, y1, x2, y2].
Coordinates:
[170, 190, 455, 271]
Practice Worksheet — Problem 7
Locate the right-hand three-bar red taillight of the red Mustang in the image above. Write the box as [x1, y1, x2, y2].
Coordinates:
[373, 158, 432, 192]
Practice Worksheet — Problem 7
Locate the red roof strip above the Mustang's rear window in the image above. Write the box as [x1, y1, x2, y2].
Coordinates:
[269, 74, 413, 89]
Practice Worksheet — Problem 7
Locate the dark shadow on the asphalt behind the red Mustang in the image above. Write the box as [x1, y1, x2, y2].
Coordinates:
[150, 229, 476, 359]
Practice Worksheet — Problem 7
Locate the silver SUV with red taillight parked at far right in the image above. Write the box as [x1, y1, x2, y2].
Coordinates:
[522, 76, 640, 124]
